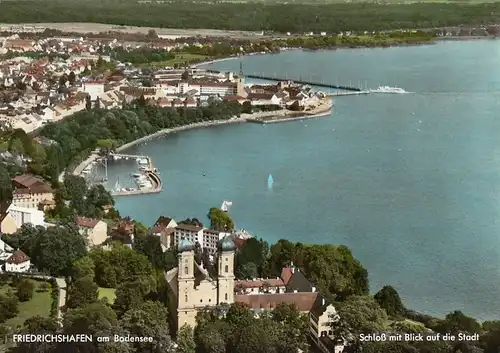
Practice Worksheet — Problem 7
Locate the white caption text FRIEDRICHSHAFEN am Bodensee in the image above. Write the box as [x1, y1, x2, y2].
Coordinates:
[12, 333, 154, 343]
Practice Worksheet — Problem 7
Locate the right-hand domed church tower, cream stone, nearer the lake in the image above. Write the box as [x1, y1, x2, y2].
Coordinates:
[217, 236, 236, 304]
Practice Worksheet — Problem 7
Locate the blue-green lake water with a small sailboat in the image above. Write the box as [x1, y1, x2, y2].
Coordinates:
[110, 40, 500, 320]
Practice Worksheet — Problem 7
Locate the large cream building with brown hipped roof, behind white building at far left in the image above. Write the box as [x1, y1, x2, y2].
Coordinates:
[12, 174, 54, 209]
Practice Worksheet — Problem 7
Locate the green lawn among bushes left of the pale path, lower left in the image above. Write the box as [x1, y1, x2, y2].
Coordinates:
[0, 280, 52, 328]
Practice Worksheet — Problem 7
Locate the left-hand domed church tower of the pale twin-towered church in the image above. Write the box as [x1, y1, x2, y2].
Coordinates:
[177, 239, 196, 329]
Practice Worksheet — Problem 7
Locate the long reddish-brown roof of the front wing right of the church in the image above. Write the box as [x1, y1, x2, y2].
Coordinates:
[234, 292, 318, 312]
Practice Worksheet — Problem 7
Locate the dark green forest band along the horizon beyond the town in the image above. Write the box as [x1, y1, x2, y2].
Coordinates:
[0, 0, 500, 33]
